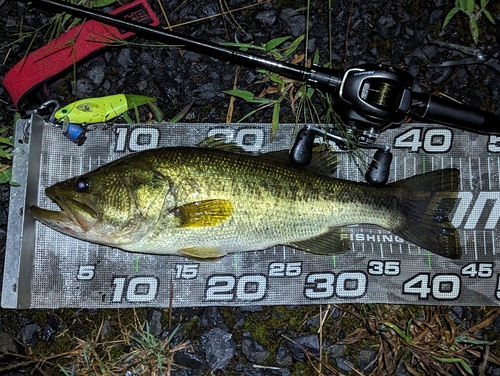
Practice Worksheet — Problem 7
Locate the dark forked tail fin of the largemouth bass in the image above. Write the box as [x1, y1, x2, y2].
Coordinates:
[389, 168, 461, 259]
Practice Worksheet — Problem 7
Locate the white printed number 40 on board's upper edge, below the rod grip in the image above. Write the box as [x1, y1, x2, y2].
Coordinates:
[394, 128, 453, 153]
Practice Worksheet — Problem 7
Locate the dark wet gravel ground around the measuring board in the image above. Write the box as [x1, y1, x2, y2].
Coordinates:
[0, 0, 500, 375]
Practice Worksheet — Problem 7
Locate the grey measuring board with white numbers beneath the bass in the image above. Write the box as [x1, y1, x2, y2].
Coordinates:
[2, 116, 500, 308]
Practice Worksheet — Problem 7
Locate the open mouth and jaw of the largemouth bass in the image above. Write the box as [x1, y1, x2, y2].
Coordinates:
[30, 195, 99, 233]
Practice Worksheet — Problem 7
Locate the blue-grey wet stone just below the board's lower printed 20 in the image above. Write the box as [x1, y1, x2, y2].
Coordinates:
[201, 328, 236, 370]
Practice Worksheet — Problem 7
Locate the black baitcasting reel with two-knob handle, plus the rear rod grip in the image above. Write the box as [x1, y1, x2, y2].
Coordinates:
[289, 64, 500, 186]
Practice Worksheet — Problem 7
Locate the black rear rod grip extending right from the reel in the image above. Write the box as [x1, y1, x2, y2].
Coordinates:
[410, 93, 500, 135]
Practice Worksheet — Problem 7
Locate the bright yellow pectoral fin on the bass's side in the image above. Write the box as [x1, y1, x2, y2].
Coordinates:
[173, 200, 234, 228]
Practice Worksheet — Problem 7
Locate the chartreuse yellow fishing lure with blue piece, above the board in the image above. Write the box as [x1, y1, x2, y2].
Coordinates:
[54, 94, 156, 145]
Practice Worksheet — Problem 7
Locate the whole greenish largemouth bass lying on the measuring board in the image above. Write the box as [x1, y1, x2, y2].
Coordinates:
[31, 141, 460, 259]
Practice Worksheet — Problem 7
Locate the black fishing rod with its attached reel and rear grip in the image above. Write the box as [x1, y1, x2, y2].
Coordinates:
[25, 0, 500, 185]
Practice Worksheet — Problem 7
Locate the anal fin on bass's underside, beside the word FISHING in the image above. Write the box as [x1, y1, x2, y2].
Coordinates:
[285, 227, 351, 255]
